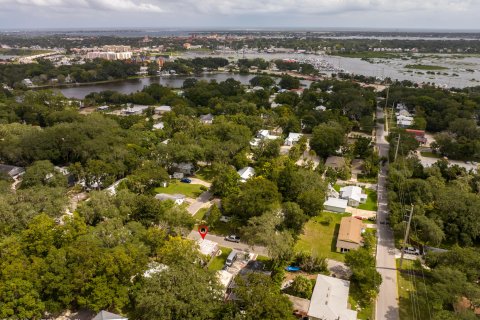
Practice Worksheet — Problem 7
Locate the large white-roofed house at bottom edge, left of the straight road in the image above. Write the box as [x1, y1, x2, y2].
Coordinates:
[307, 274, 357, 320]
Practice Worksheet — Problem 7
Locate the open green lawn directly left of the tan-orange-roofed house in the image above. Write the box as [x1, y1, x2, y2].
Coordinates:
[295, 212, 350, 262]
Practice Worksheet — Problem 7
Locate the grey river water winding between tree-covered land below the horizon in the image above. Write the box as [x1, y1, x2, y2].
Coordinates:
[59, 52, 480, 99]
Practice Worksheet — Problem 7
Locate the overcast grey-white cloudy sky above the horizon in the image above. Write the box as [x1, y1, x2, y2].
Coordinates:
[0, 0, 480, 30]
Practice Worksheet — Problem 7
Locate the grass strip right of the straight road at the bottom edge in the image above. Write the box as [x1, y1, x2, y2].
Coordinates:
[397, 259, 430, 320]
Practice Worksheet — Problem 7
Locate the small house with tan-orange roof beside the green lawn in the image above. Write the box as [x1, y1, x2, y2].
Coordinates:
[337, 217, 365, 253]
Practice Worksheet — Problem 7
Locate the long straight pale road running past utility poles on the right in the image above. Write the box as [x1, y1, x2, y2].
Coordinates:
[375, 109, 399, 320]
